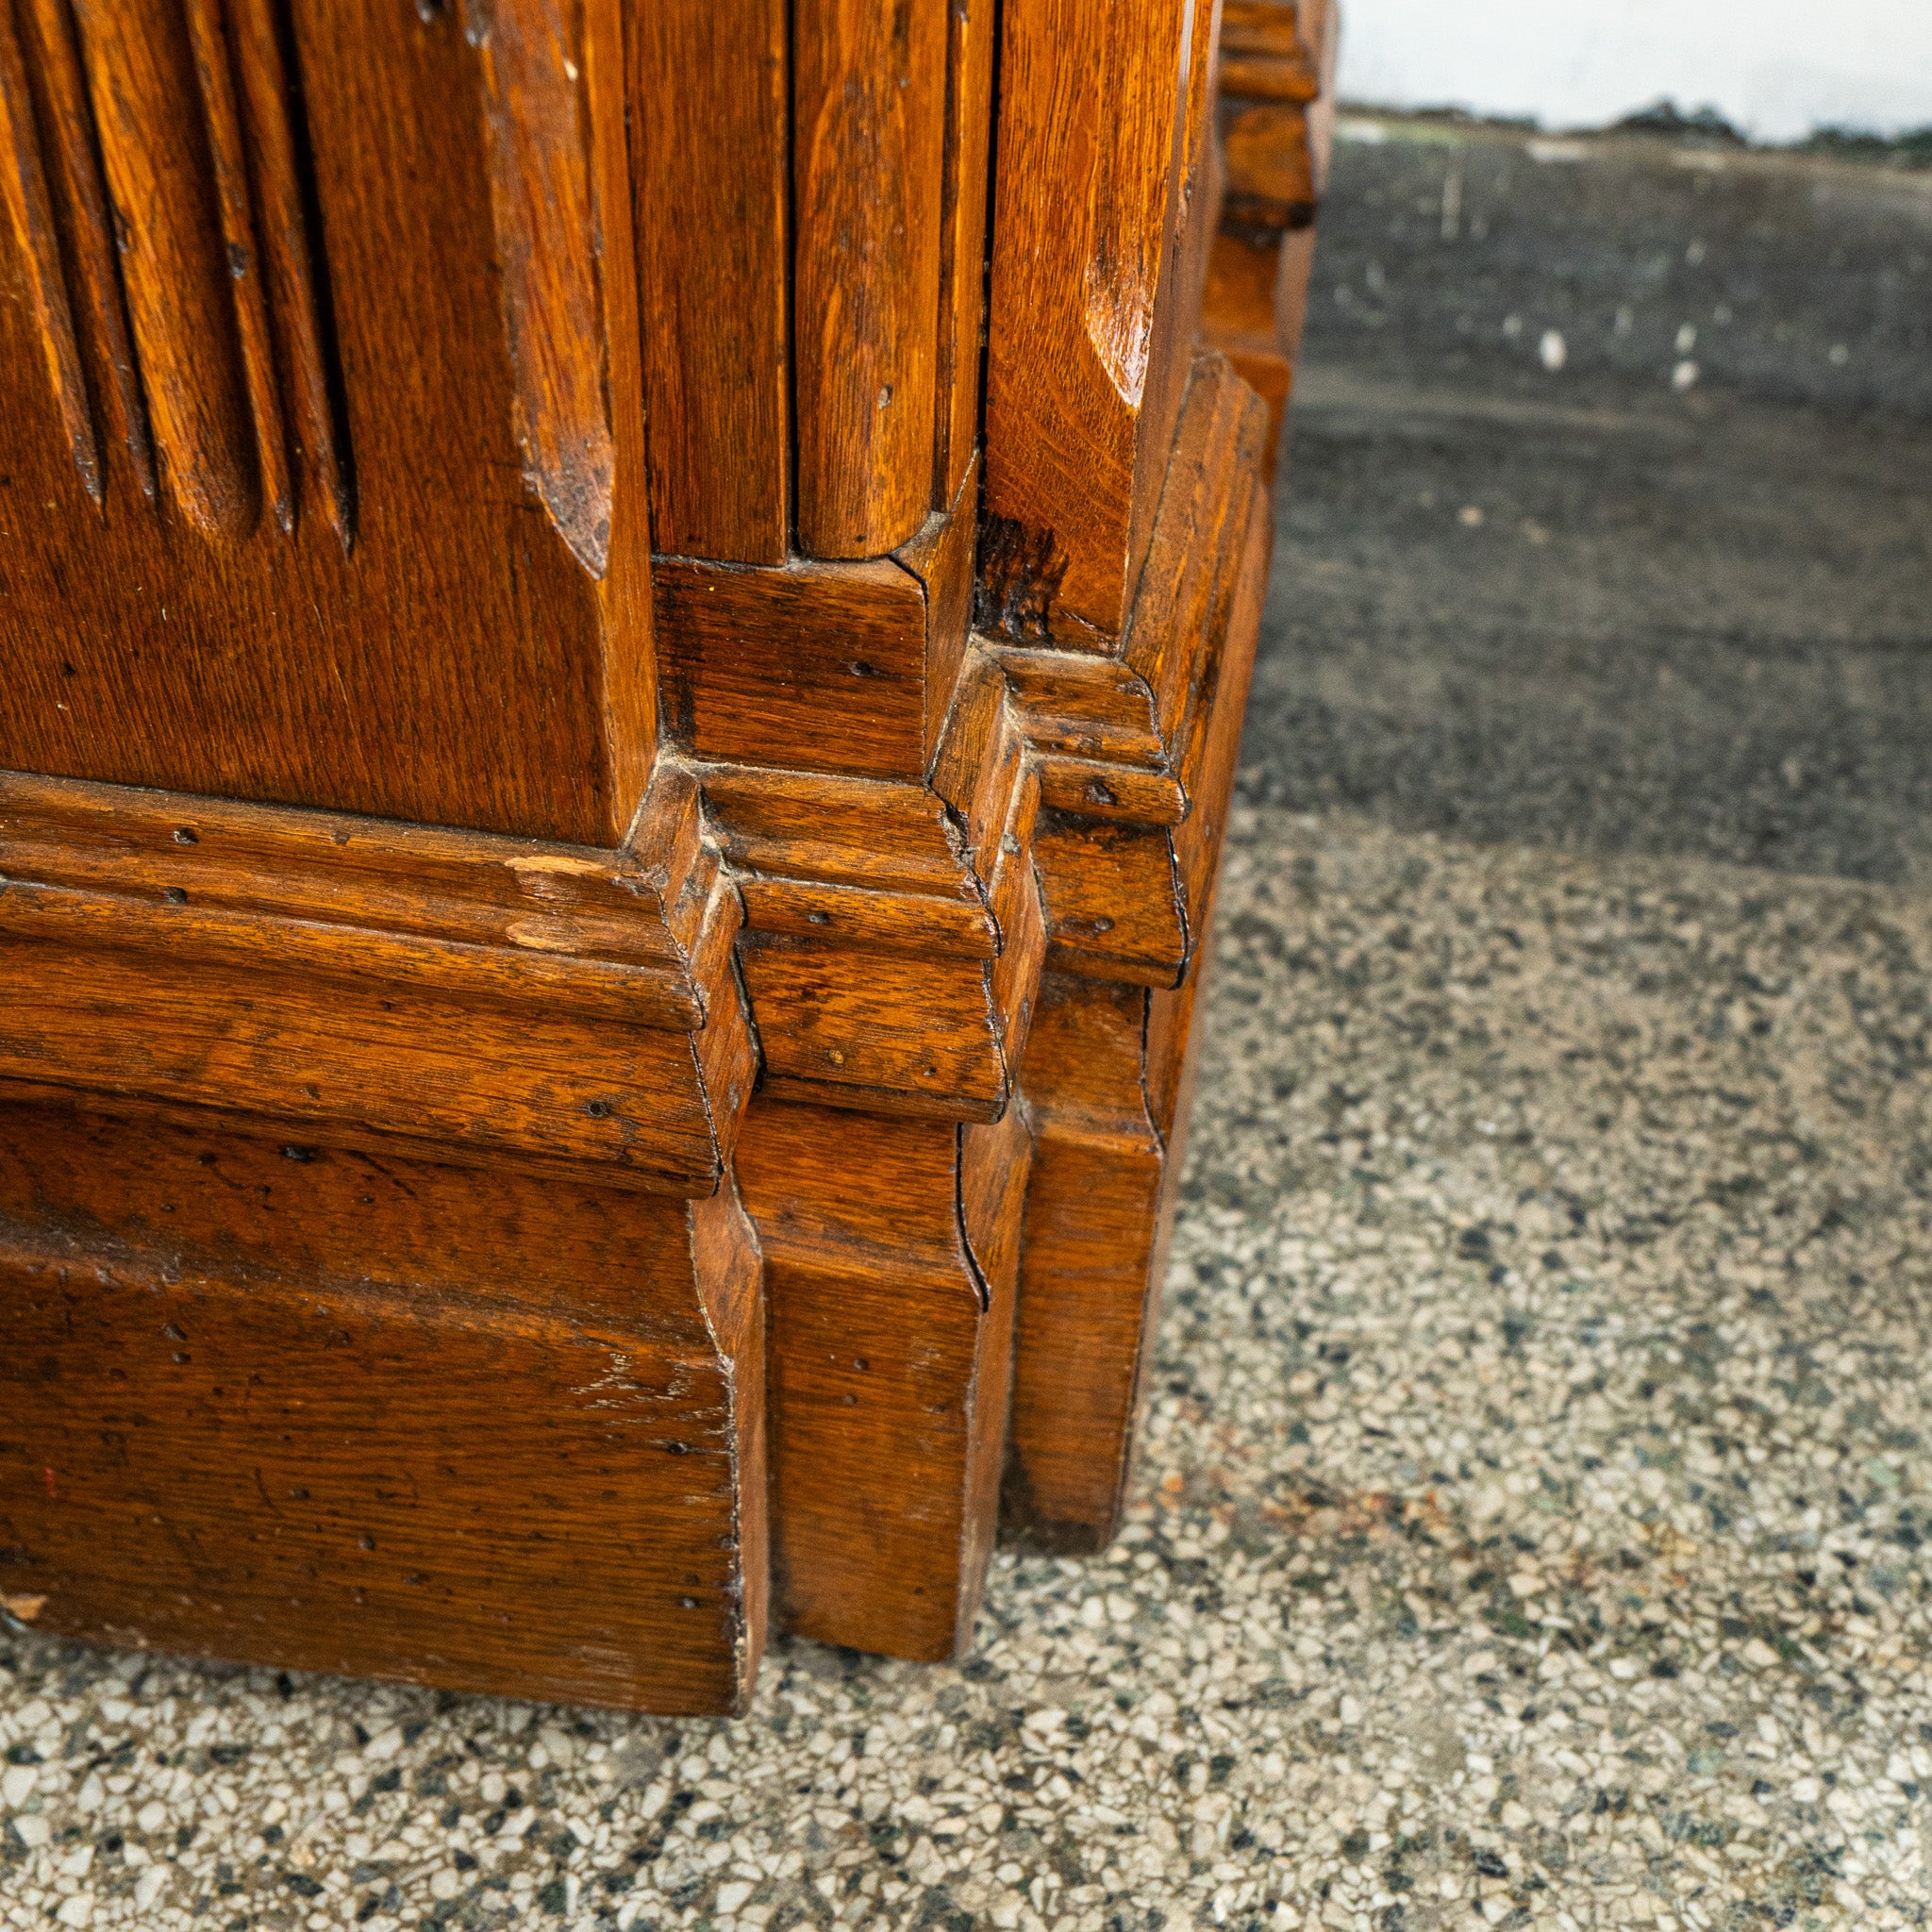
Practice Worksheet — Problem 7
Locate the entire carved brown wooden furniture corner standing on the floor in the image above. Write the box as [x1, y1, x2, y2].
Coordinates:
[0, 0, 1335, 1712]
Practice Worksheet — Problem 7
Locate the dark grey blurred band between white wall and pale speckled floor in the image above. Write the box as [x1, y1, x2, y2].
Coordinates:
[1246, 118, 1932, 887]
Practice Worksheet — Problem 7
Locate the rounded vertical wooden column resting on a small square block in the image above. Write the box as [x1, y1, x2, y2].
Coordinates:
[792, 0, 947, 557]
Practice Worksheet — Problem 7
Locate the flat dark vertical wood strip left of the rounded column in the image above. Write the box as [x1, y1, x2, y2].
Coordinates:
[626, 0, 792, 564]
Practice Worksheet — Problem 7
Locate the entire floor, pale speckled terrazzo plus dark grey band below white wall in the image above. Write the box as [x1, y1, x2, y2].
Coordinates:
[0, 125, 1932, 1932]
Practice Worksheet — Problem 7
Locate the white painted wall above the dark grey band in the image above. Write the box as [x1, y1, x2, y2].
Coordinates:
[1339, 0, 1932, 142]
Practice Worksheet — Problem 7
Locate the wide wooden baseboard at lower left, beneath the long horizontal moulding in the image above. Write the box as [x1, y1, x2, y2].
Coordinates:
[0, 1105, 767, 1712]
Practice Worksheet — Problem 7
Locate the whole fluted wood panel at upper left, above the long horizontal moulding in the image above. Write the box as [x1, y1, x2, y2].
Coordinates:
[0, 0, 655, 844]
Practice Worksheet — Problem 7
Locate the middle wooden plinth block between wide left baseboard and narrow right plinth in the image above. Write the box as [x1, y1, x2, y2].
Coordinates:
[738, 1101, 1028, 1659]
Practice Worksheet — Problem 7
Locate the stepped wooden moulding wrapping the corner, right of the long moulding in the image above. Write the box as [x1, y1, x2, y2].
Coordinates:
[675, 356, 1265, 1121]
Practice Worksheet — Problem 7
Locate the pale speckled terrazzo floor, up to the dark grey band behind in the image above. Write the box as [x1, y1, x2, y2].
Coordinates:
[0, 125, 1932, 1932]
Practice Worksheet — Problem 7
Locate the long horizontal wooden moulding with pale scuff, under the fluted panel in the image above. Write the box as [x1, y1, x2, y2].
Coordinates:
[0, 771, 754, 1194]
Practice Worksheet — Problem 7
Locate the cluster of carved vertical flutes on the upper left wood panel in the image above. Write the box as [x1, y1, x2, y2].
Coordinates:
[0, 0, 352, 542]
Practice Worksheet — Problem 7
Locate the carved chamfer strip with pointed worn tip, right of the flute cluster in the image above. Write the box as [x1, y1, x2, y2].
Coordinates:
[464, 0, 614, 577]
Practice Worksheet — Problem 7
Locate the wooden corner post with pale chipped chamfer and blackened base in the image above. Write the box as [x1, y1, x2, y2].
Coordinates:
[977, 0, 1213, 649]
